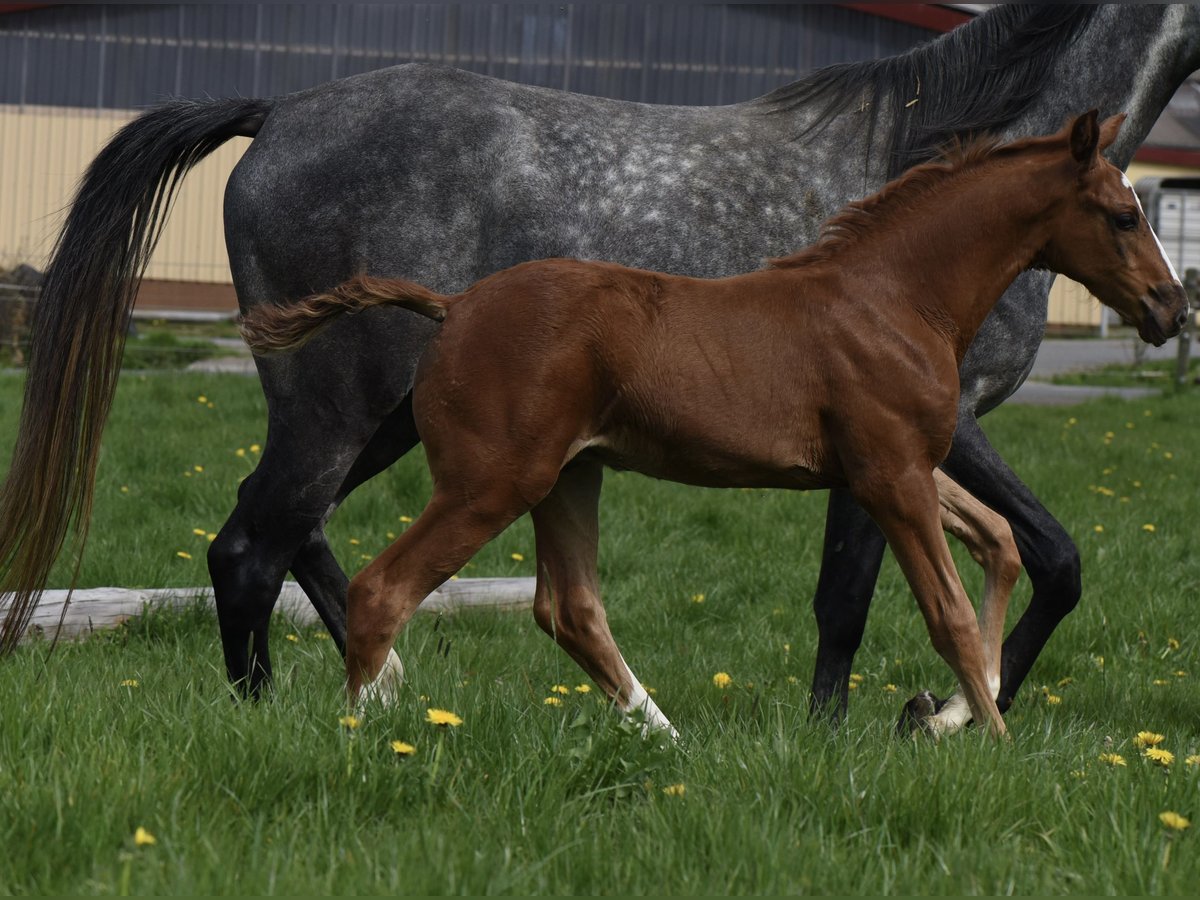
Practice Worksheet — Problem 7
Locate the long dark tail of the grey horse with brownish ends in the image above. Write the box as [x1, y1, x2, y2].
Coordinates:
[0, 100, 272, 653]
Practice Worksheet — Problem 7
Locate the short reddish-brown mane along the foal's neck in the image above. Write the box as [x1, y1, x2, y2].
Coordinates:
[767, 136, 1061, 269]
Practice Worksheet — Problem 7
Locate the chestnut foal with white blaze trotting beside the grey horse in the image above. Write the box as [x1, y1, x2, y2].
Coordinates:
[242, 110, 1187, 733]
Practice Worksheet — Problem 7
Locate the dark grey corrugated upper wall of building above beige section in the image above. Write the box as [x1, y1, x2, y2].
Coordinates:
[0, 2, 932, 109]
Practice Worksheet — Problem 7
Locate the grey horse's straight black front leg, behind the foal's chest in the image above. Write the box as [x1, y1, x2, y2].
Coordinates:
[809, 490, 886, 722]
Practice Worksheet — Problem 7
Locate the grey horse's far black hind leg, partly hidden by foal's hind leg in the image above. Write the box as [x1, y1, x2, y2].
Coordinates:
[283, 394, 420, 656]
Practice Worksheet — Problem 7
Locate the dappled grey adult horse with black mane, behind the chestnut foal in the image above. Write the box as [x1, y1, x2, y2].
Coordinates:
[0, 5, 1200, 715]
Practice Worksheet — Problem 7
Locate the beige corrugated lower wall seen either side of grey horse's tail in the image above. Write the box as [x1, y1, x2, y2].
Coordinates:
[0, 106, 250, 283]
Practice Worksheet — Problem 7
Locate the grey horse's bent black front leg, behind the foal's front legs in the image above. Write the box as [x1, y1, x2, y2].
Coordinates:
[942, 416, 1082, 712]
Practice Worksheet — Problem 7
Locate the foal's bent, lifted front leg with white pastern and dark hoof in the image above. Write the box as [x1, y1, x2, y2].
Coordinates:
[900, 470, 1021, 733]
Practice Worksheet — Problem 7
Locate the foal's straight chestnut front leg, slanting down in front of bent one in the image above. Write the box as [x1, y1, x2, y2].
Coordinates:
[852, 466, 1006, 734]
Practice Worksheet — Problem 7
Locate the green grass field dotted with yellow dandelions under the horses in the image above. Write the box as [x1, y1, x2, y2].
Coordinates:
[0, 374, 1200, 894]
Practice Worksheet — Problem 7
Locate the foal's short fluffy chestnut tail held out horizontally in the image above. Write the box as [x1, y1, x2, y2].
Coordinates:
[241, 275, 457, 354]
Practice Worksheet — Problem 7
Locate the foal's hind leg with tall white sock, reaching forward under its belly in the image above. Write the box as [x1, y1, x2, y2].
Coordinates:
[532, 462, 677, 737]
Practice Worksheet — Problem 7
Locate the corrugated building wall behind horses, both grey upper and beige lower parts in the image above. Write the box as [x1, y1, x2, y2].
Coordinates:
[0, 2, 932, 302]
